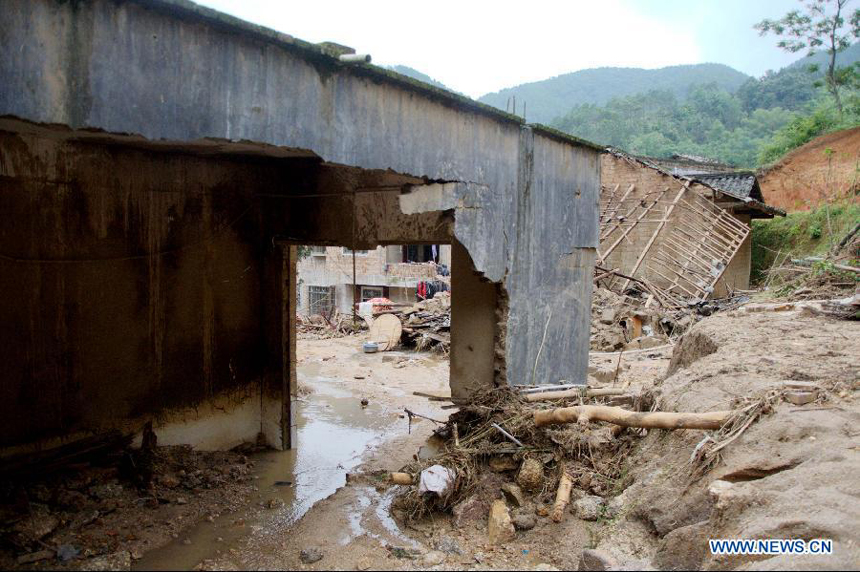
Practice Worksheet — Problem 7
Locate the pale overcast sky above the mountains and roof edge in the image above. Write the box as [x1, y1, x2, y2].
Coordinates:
[193, 0, 799, 97]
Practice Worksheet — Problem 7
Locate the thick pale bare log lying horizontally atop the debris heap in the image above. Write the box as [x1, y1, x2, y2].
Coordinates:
[534, 405, 734, 429]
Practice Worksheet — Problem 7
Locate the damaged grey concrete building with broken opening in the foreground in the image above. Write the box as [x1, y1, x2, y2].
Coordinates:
[0, 0, 601, 457]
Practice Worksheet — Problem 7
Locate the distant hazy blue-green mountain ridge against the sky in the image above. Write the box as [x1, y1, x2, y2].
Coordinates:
[478, 64, 750, 124]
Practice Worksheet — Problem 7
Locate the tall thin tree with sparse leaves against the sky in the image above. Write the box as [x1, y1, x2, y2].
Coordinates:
[755, 0, 860, 117]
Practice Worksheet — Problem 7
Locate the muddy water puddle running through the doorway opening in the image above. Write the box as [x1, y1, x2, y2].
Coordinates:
[133, 374, 391, 570]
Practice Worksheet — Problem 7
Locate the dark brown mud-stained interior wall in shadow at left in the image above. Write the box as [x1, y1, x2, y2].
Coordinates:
[0, 131, 290, 445]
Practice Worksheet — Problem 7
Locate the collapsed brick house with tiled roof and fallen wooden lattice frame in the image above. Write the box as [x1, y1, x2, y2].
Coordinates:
[597, 148, 785, 308]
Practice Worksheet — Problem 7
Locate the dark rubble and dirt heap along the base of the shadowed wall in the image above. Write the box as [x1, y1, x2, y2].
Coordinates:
[0, 438, 255, 569]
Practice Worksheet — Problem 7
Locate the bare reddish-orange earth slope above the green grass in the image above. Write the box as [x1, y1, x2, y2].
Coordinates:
[758, 127, 860, 212]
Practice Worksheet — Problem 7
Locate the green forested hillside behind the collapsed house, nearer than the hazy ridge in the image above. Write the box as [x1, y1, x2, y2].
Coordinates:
[552, 44, 860, 167]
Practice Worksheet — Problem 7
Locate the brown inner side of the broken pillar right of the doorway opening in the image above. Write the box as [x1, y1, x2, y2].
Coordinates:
[450, 240, 497, 397]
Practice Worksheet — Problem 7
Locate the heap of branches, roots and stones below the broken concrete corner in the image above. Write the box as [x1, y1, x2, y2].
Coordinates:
[391, 388, 652, 528]
